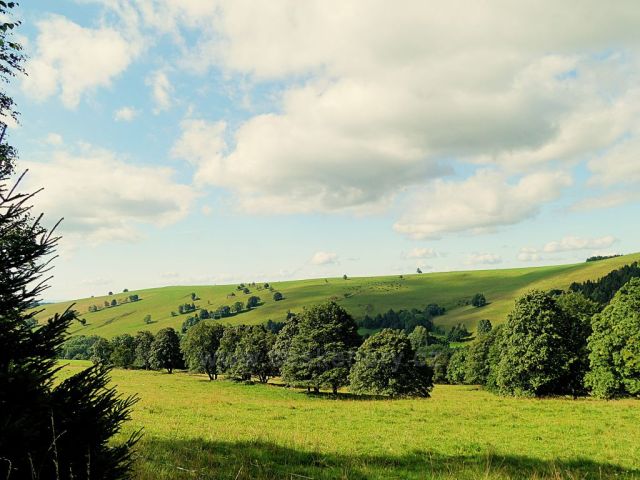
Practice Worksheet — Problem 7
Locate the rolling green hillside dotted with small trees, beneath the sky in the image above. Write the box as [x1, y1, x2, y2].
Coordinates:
[38, 254, 640, 337]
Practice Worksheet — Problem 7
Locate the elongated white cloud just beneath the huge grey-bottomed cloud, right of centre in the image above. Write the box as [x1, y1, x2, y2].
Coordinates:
[394, 170, 571, 239]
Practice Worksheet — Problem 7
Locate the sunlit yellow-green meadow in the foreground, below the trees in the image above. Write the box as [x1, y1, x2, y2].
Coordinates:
[61, 361, 640, 479]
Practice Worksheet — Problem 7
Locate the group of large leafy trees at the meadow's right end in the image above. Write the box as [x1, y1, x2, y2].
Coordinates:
[445, 279, 640, 398]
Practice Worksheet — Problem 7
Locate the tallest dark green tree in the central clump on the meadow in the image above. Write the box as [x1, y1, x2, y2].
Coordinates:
[282, 302, 360, 393]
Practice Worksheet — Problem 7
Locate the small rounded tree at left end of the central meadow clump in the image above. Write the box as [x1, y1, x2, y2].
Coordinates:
[180, 322, 224, 380]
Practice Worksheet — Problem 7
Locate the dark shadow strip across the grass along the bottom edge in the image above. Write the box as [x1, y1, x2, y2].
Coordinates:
[136, 438, 640, 480]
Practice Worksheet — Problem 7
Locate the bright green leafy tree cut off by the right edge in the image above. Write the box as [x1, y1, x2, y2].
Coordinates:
[585, 278, 640, 398]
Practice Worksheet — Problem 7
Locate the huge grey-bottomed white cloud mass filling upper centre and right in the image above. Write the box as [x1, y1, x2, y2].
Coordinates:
[159, 0, 638, 230]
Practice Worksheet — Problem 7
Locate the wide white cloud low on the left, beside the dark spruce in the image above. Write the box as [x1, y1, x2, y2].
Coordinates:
[23, 145, 196, 243]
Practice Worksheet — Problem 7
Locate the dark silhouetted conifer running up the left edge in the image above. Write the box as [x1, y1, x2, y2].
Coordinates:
[0, 7, 136, 480]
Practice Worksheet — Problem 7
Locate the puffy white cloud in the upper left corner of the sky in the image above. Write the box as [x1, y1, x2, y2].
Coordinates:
[23, 15, 141, 108]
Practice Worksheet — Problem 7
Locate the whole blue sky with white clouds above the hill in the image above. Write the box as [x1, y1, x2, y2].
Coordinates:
[2, 0, 640, 300]
